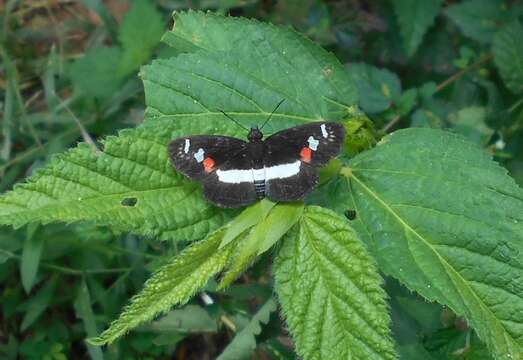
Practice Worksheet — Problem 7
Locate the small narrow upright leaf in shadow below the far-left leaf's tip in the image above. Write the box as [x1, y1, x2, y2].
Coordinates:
[20, 224, 45, 294]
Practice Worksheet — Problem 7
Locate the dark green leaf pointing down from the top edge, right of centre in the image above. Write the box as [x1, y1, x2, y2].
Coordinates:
[392, 0, 442, 57]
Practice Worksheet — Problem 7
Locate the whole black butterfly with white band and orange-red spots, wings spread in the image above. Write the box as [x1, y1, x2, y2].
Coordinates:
[169, 114, 345, 208]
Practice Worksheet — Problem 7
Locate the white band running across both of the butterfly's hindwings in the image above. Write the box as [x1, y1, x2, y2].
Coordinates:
[216, 160, 301, 184]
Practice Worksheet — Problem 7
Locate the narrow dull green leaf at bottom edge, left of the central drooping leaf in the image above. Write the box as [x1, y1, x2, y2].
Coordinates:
[217, 298, 276, 360]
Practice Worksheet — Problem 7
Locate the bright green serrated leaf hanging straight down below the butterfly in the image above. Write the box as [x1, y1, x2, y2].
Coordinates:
[275, 206, 395, 360]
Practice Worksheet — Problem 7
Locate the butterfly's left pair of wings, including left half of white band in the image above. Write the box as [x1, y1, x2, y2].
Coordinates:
[169, 135, 258, 208]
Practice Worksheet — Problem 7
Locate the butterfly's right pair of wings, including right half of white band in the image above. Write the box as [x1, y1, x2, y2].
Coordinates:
[264, 122, 345, 201]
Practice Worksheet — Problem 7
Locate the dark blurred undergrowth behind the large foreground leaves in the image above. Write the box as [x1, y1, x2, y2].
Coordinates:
[0, 0, 523, 359]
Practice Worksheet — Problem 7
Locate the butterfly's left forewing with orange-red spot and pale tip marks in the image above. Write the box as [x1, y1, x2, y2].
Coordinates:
[169, 135, 247, 180]
